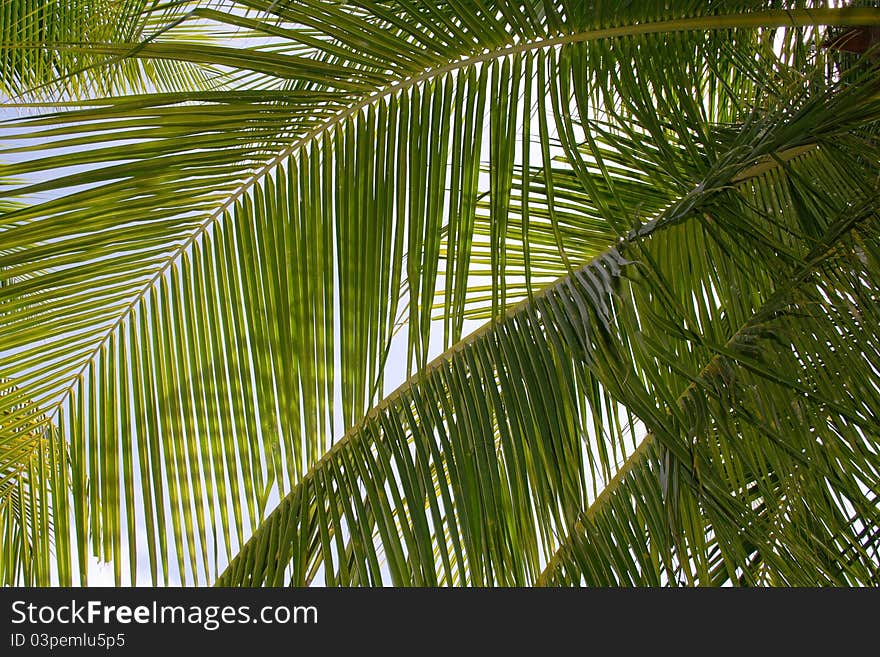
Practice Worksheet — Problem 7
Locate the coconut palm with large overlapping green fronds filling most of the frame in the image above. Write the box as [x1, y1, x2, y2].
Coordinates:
[0, 0, 880, 585]
